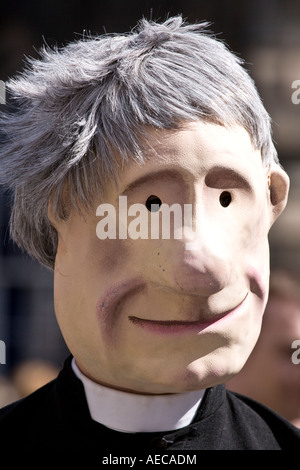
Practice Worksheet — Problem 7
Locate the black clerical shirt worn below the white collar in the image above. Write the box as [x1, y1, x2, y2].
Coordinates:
[0, 357, 300, 456]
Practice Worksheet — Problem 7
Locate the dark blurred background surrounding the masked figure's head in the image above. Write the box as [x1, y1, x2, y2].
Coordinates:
[0, 0, 300, 406]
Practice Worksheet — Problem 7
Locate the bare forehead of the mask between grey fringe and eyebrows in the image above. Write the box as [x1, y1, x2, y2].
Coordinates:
[114, 123, 266, 195]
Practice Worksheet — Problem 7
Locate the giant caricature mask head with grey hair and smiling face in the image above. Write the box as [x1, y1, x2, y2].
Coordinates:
[1, 18, 288, 393]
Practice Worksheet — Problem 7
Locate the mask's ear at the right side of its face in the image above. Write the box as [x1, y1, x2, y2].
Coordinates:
[268, 163, 290, 225]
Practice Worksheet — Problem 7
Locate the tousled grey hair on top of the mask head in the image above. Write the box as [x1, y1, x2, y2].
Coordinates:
[0, 16, 278, 268]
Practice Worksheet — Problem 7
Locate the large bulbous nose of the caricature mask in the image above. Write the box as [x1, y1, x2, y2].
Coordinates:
[152, 187, 232, 296]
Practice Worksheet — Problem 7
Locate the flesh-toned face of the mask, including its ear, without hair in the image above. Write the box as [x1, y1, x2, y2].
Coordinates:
[53, 122, 288, 393]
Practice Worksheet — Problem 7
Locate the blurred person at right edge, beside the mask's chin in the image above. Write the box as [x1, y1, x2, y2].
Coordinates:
[227, 270, 300, 428]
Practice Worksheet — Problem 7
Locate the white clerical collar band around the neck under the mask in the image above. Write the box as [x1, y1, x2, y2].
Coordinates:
[72, 358, 205, 433]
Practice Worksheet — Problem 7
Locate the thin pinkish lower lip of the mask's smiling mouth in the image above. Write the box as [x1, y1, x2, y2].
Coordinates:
[128, 293, 248, 333]
